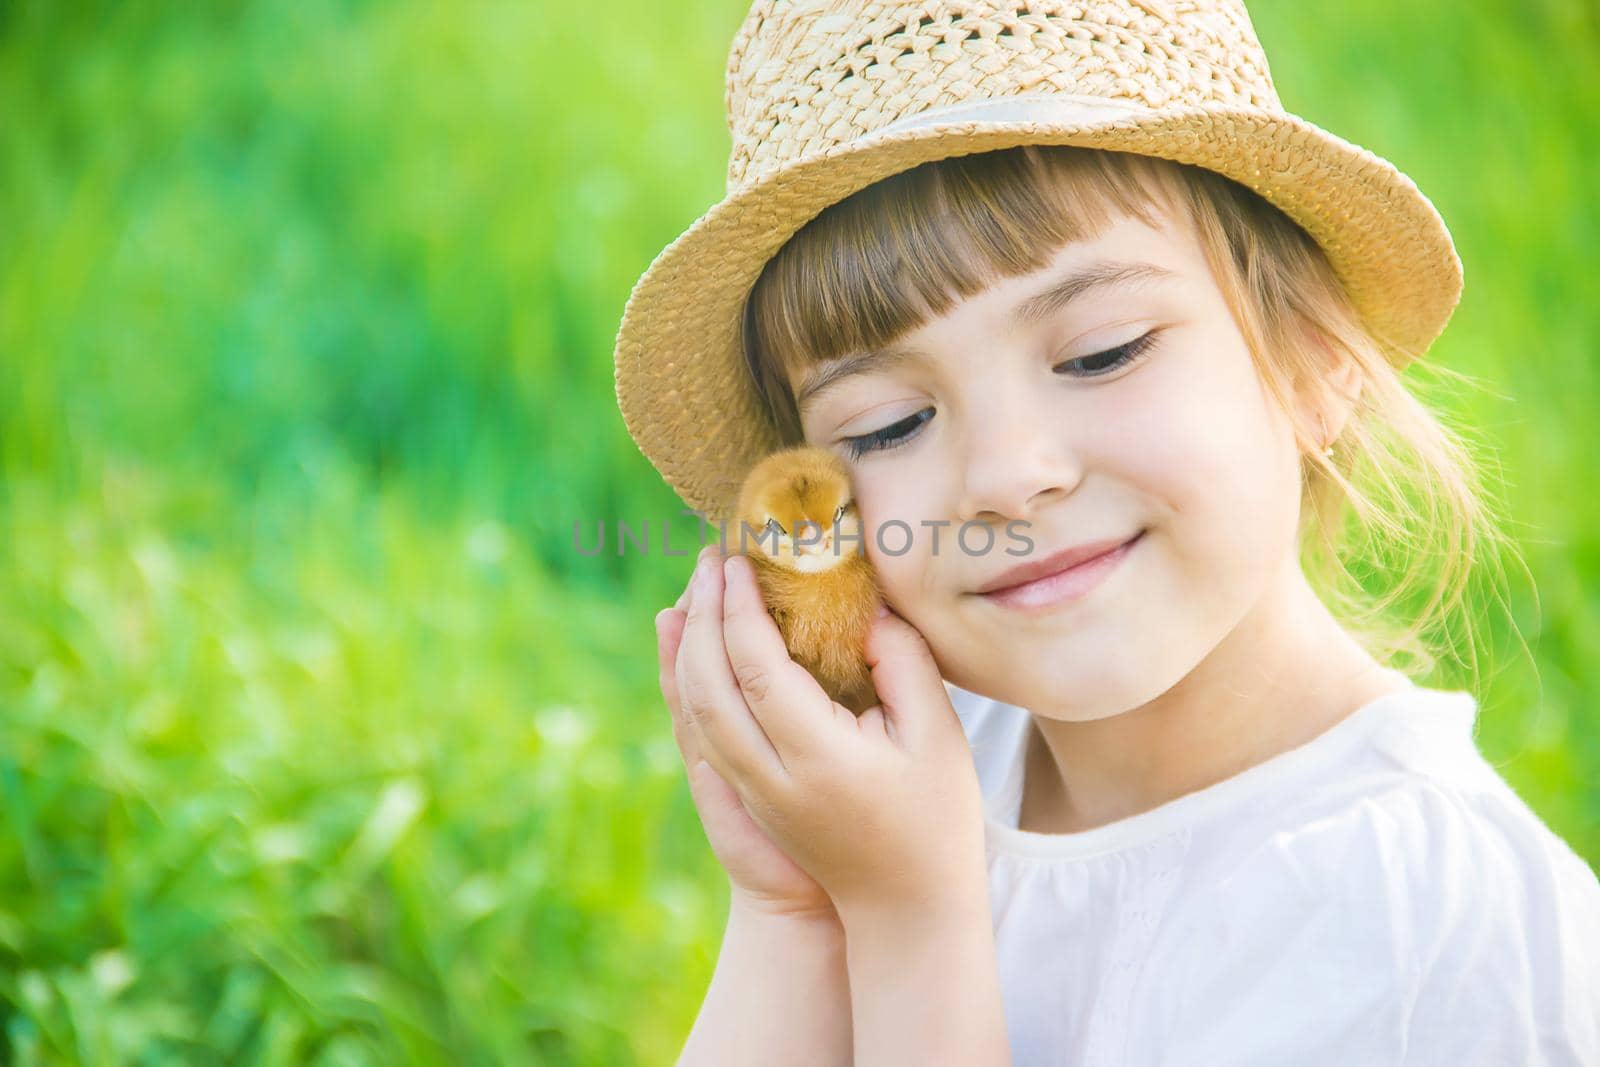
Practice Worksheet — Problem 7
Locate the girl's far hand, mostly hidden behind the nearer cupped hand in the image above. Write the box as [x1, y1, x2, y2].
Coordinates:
[656, 549, 838, 923]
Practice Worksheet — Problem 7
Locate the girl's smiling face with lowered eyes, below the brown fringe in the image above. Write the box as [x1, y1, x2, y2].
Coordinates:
[790, 202, 1301, 720]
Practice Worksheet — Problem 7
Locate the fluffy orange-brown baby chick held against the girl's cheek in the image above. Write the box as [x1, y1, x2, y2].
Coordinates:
[726, 448, 880, 715]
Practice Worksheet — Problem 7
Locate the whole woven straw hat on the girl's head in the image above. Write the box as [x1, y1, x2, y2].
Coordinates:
[616, 0, 1461, 522]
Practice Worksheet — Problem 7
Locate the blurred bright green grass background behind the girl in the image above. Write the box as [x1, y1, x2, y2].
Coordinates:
[0, 0, 1600, 1064]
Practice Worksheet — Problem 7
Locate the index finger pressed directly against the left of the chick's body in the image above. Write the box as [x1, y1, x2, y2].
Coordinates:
[722, 555, 856, 765]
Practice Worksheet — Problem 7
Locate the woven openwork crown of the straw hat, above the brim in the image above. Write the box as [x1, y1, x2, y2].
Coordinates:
[726, 0, 1282, 192]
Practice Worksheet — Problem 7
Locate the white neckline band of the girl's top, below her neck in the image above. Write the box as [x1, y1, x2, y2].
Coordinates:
[984, 681, 1430, 859]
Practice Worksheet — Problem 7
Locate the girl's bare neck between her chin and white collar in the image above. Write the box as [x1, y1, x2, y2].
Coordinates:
[1021, 558, 1408, 833]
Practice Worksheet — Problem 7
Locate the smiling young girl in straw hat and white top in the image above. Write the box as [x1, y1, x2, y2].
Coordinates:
[618, 0, 1600, 1065]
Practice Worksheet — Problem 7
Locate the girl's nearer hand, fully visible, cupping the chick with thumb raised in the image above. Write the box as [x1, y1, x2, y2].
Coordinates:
[677, 553, 989, 929]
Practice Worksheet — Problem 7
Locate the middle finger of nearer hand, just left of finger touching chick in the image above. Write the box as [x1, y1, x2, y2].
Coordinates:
[677, 557, 786, 789]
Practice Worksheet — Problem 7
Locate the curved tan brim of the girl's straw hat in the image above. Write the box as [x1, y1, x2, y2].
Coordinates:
[616, 104, 1462, 523]
